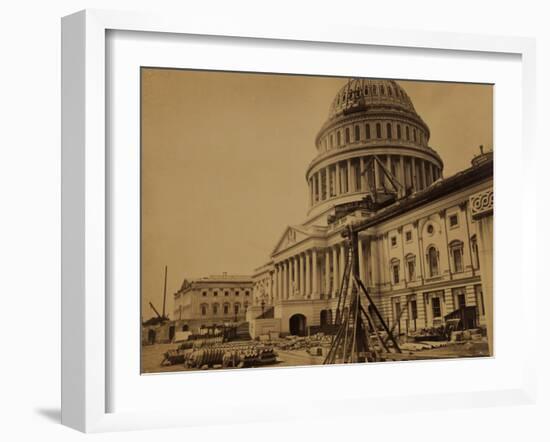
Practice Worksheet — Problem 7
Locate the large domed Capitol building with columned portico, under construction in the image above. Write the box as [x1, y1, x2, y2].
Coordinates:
[247, 79, 493, 340]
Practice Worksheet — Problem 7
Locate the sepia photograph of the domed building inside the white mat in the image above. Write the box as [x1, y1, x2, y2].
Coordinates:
[136, 67, 494, 374]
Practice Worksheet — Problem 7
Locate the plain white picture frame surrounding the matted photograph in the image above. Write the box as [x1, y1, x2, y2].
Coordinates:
[62, 10, 536, 432]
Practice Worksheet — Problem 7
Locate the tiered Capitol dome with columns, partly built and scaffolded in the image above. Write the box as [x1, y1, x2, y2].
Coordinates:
[306, 79, 443, 217]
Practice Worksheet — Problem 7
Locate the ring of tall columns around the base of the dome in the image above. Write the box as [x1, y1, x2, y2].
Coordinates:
[309, 155, 441, 206]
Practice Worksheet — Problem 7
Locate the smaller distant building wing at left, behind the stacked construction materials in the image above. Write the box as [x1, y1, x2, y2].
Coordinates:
[173, 274, 252, 332]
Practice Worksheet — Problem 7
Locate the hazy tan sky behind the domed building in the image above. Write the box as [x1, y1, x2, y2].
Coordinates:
[142, 69, 493, 319]
